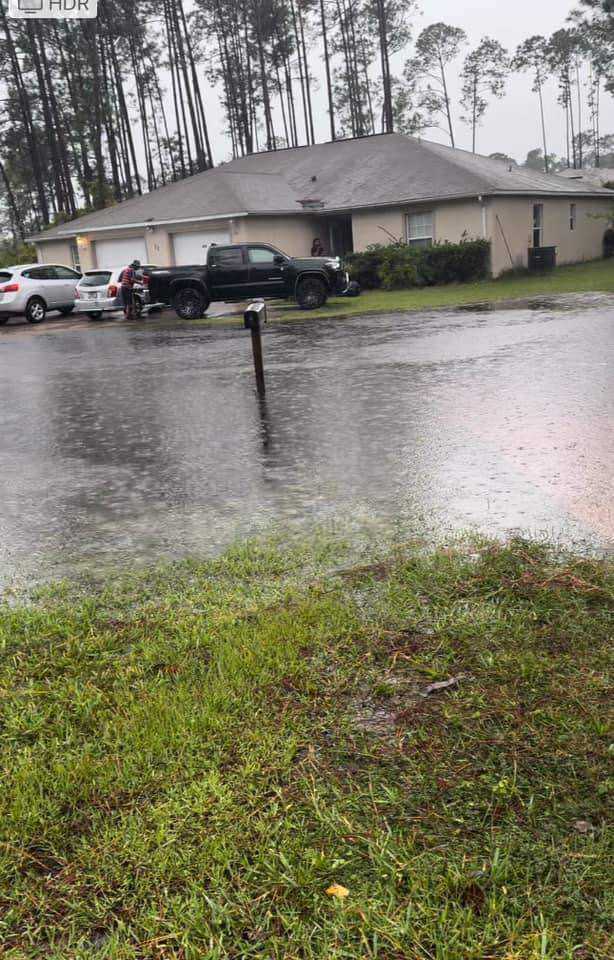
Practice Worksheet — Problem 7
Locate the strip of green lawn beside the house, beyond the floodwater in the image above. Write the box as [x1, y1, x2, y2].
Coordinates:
[274, 260, 614, 320]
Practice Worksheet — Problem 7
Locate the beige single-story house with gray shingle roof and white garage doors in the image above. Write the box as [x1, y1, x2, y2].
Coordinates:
[30, 134, 614, 275]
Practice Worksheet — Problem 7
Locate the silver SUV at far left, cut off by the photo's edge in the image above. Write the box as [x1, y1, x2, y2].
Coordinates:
[0, 263, 81, 324]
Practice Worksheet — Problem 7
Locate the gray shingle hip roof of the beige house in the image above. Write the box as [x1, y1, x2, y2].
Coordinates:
[33, 134, 612, 240]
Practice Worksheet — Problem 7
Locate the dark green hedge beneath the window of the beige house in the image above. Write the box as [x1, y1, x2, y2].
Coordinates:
[347, 240, 490, 290]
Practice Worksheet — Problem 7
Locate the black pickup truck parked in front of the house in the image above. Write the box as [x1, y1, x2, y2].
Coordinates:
[143, 243, 349, 320]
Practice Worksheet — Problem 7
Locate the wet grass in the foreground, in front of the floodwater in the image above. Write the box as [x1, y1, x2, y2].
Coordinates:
[0, 541, 614, 960]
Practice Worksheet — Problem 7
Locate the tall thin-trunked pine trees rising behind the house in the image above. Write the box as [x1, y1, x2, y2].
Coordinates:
[0, 0, 614, 246]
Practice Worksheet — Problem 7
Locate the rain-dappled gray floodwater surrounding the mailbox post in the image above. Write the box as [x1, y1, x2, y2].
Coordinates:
[0, 295, 614, 584]
